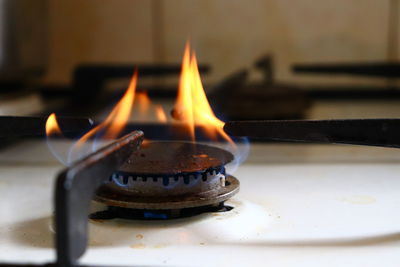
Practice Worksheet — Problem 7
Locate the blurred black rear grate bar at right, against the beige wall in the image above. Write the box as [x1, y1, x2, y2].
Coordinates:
[293, 62, 400, 78]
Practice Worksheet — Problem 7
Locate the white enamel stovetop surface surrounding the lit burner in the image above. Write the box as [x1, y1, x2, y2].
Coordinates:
[0, 141, 400, 267]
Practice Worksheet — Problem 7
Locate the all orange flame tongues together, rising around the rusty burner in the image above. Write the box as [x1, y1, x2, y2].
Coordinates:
[46, 43, 236, 168]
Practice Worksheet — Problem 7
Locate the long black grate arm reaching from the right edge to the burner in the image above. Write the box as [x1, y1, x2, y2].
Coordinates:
[224, 119, 400, 148]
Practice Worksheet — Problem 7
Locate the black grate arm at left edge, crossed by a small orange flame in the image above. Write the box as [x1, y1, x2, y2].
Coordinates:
[0, 116, 93, 138]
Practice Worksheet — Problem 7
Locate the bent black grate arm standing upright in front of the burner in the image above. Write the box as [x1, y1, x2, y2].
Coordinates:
[55, 131, 143, 267]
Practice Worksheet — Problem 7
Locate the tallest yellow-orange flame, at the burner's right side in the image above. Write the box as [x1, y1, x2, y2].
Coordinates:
[173, 42, 233, 144]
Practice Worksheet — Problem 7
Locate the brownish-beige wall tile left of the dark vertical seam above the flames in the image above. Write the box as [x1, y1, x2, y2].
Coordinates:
[46, 0, 153, 83]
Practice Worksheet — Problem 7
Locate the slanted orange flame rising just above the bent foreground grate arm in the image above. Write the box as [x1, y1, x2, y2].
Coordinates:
[74, 71, 137, 146]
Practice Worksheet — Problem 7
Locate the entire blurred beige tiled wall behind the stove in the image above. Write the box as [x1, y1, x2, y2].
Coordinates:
[46, 0, 389, 83]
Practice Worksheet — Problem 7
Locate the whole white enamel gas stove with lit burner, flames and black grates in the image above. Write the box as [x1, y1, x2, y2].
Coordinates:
[0, 40, 400, 267]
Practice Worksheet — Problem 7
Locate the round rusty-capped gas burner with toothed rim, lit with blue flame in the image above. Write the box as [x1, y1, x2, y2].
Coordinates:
[92, 142, 239, 219]
